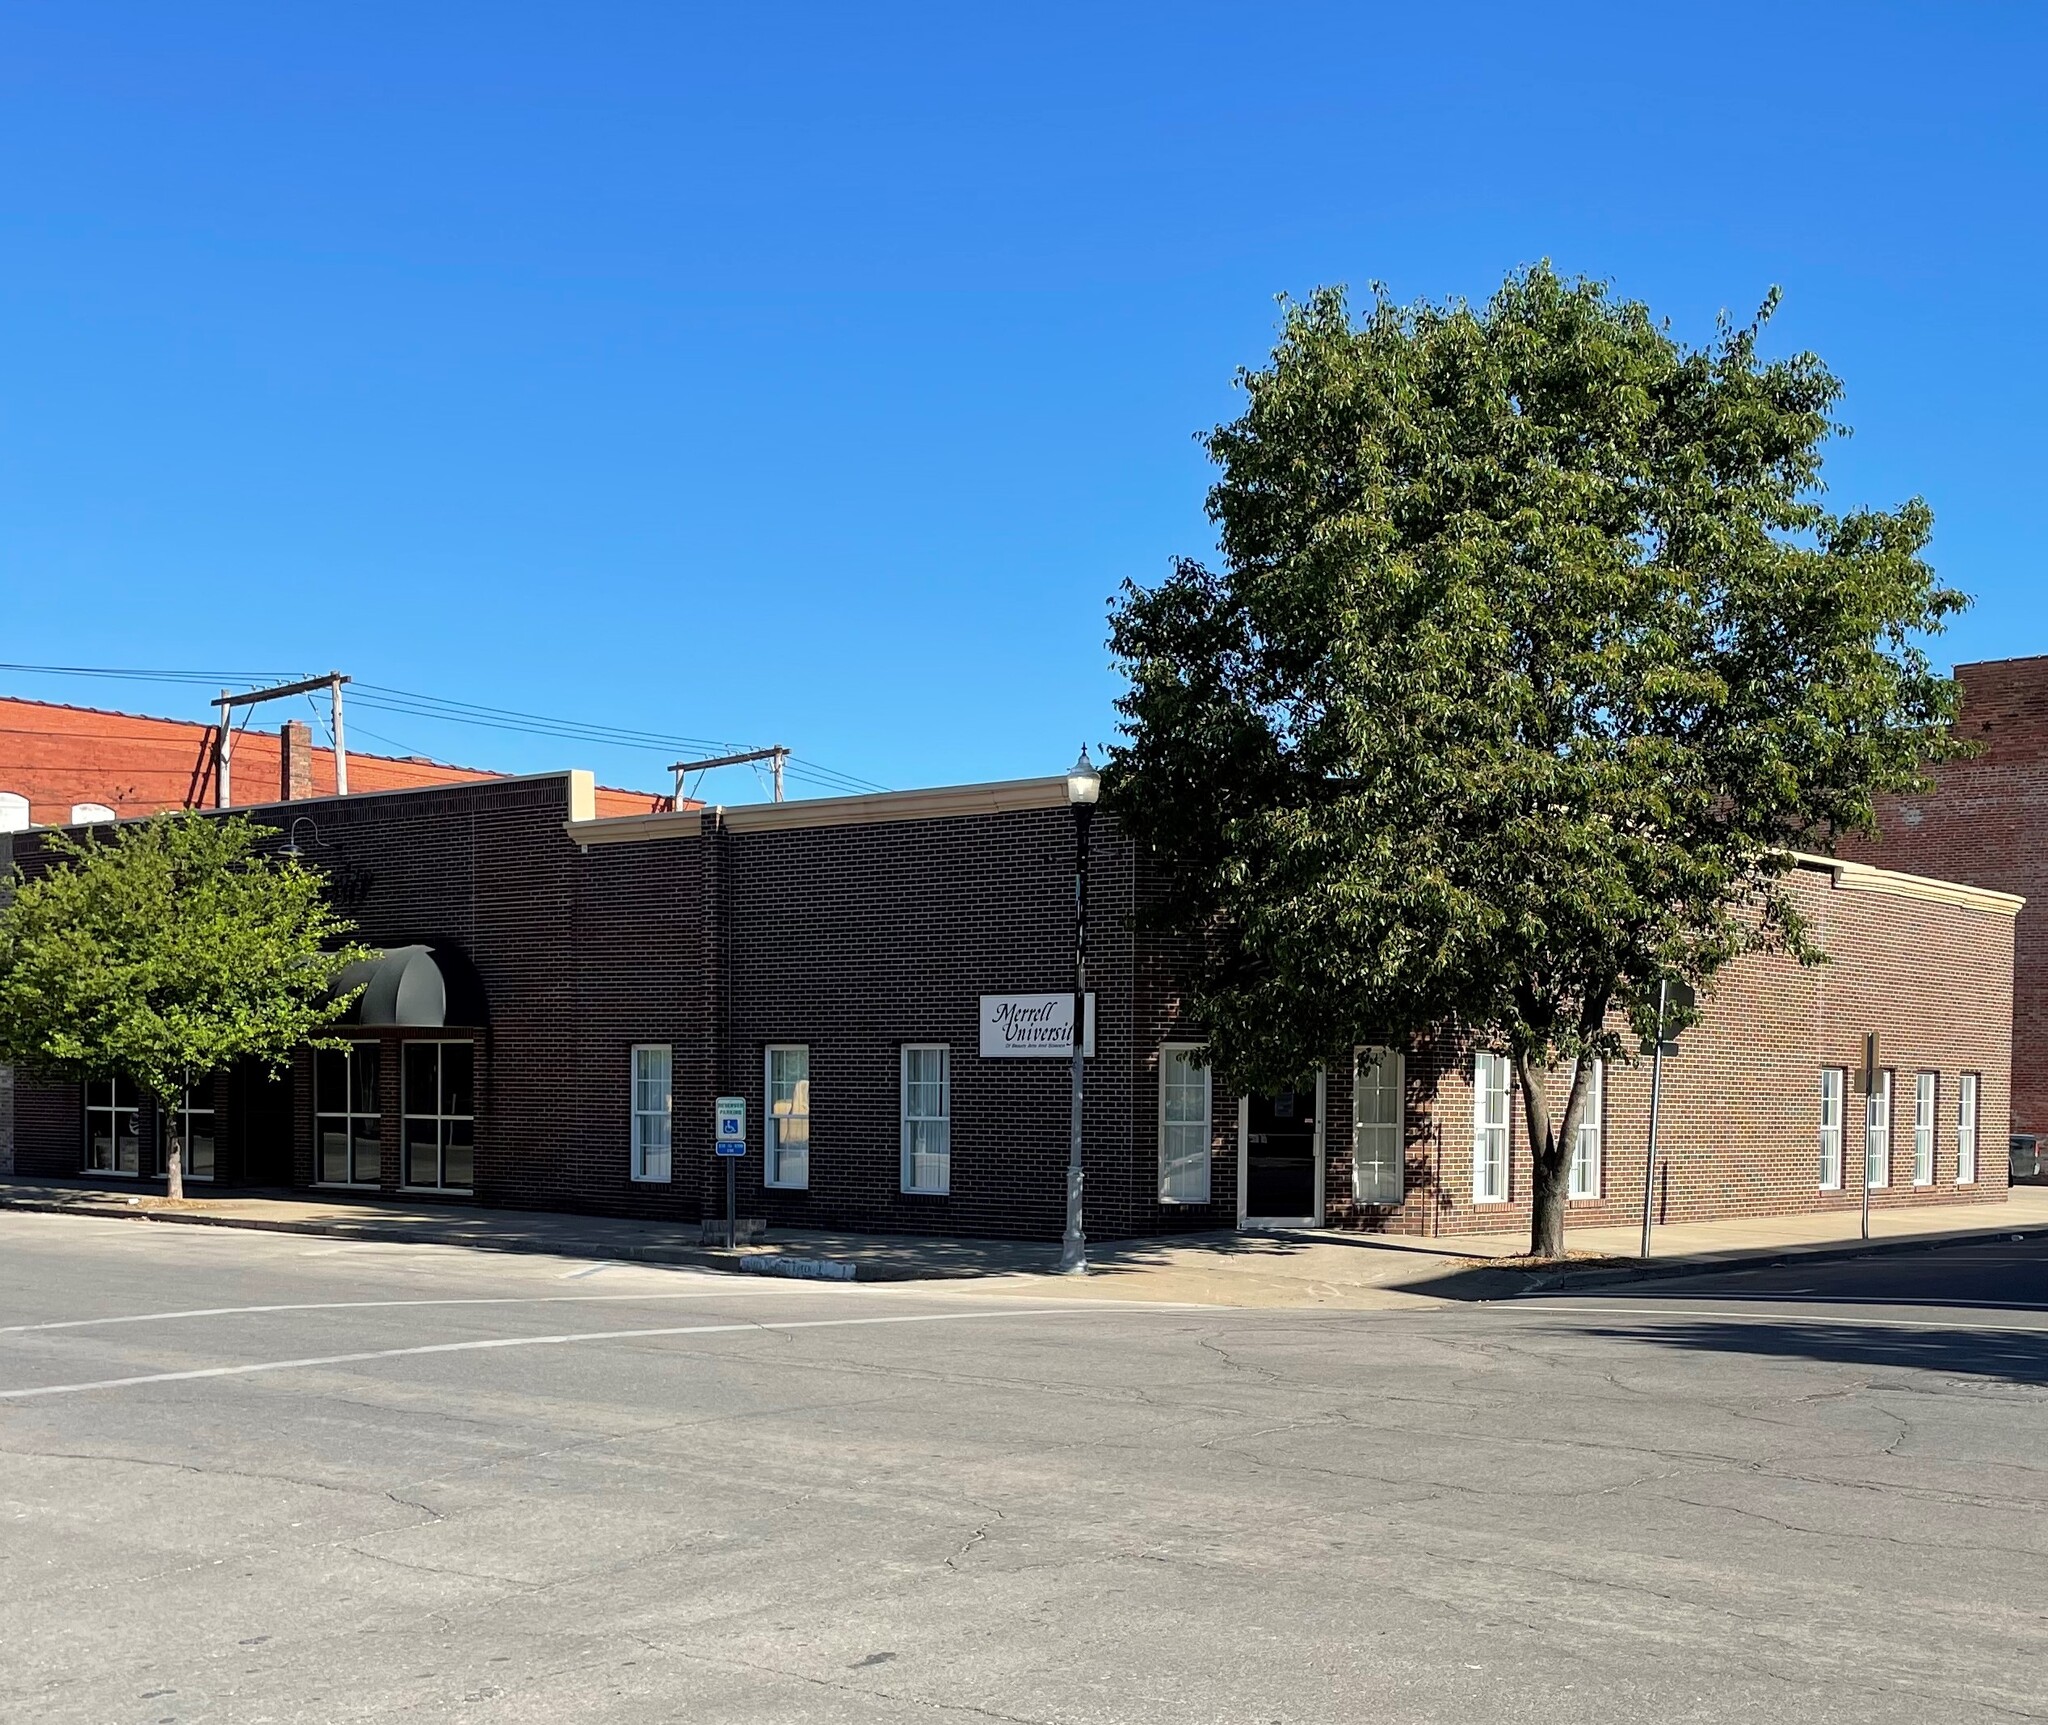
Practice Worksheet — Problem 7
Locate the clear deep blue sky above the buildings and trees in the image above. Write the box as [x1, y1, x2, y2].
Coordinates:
[0, 0, 2048, 799]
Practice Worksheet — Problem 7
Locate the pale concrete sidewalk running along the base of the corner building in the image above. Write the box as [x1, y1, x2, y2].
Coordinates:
[0, 1178, 2048, 1307]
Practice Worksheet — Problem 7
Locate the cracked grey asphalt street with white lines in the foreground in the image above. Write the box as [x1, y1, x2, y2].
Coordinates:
[0, 1215, 2048, 1725]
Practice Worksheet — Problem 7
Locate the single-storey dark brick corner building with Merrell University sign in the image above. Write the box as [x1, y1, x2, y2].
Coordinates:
[0, 774, 2019, 1237]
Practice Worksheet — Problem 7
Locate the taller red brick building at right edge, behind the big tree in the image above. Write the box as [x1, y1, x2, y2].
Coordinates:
[1841, 658, 2048, 1137]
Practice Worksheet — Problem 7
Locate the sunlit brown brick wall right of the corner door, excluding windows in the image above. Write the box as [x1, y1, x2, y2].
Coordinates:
[1327, 869, 2013, 1233]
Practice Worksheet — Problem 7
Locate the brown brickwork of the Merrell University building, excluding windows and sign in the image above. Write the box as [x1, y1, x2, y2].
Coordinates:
[0, 776, 2013, 1237]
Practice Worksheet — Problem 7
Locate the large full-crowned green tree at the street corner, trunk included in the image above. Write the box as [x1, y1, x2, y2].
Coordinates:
[1106, 266, 1966, 1256]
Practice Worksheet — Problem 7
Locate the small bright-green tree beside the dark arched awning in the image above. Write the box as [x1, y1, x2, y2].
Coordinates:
[0, 811, 367, 1198]
